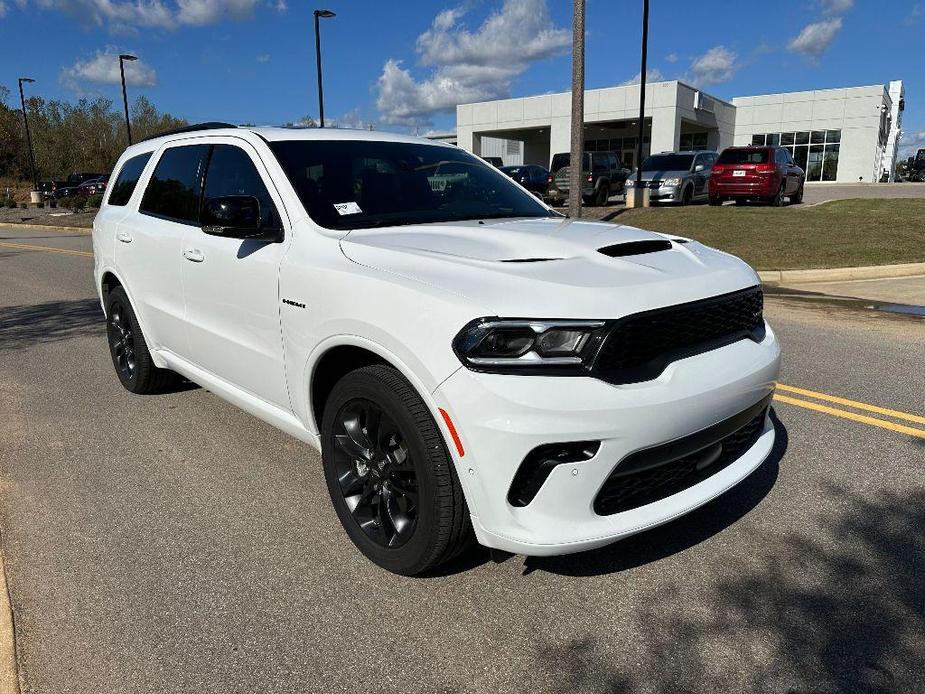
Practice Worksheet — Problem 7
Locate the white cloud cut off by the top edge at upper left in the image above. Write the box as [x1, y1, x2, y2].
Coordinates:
[27, 0, 286, 31]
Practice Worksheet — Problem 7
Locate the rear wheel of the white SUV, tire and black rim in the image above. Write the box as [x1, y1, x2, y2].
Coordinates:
[106, 287, 177, 395]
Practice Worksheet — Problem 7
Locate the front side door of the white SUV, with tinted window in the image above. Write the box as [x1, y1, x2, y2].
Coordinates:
[182, 138, 290, 410]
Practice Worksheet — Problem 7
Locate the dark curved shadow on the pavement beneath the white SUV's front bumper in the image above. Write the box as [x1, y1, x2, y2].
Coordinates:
[524, 408, 788, 576]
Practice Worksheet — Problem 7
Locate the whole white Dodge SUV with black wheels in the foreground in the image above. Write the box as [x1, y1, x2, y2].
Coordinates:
[93, 126, 780, 575]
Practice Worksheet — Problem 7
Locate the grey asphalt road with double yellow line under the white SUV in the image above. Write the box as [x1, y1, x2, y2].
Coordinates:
[0, 227, 925, 693]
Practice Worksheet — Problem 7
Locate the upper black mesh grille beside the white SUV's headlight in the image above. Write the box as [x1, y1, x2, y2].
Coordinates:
[593, 287, 764, 383]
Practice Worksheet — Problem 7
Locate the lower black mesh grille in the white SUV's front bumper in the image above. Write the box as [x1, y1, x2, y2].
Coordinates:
[594, 398, 770, 516]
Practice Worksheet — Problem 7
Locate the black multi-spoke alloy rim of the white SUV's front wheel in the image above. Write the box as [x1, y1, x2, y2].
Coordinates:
[334, 398, 418, 548]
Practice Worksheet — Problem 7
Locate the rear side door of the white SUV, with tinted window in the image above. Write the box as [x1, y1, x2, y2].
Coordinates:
[113, 143, 209, 355]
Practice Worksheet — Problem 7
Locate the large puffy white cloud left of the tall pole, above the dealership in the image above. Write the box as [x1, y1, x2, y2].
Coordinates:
[376, 0, 571, 125]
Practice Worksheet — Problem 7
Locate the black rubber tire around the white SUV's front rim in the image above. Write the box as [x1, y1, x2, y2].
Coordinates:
[321, 367, 452, 575]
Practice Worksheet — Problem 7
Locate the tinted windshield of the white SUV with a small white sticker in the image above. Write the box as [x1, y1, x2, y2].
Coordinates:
[270, 140, 556, 229]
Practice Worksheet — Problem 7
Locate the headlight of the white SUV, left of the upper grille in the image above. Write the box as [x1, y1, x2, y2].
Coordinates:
[453, 318, 605, 375]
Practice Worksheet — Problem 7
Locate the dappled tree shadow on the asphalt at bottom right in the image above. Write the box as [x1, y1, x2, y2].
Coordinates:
[535, 485, 925, 692]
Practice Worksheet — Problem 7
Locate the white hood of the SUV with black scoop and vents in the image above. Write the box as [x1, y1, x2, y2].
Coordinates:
[341, 218, 758, 318]
